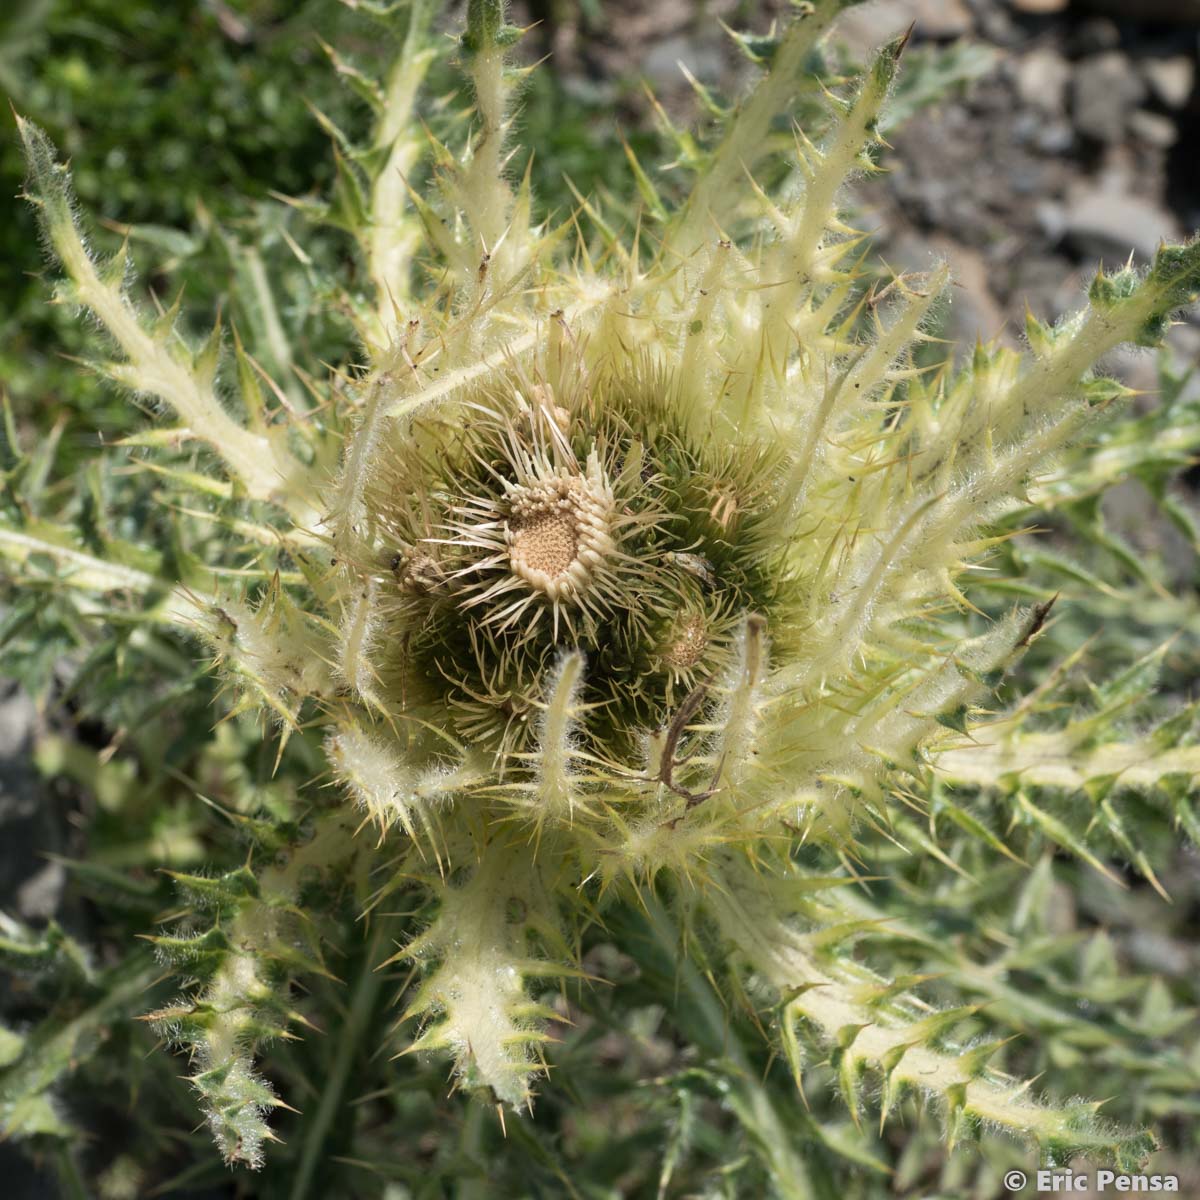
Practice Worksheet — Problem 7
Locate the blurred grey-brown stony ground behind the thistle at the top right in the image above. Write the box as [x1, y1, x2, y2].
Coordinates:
[524, 0, 1200, 388]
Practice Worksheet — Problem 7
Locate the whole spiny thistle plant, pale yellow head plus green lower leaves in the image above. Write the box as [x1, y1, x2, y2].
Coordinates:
[7, 0, 1200, 1198]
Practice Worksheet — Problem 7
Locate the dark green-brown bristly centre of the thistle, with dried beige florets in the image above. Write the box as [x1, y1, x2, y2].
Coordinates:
[362, 355, 785, 773]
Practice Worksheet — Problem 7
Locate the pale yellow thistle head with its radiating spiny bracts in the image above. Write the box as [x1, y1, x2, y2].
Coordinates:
[11, 0, 1200, 1180]
